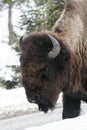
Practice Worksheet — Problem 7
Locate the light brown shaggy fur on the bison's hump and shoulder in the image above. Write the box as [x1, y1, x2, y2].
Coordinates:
[53, 0, 87, 91]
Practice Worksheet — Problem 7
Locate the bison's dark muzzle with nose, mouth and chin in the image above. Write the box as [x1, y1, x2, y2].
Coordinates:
[25, 88, 54, 113]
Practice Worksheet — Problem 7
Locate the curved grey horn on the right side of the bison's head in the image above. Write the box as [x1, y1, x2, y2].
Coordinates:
[48, 34, 61, 59]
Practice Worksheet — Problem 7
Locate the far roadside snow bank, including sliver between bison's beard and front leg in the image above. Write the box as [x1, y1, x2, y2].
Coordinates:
[0, 87, 62, 116]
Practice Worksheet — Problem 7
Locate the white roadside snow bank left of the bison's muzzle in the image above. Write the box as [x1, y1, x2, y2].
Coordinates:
[0, 88, 37, 119]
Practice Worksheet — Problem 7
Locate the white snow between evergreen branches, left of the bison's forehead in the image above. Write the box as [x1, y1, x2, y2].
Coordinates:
[0, 43, 20, 80]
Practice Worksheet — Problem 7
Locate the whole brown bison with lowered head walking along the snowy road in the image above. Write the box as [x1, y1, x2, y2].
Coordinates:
[20, 0, 87, 119]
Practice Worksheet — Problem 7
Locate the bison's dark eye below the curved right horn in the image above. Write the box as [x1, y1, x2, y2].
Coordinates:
[40, 66, 52, 80]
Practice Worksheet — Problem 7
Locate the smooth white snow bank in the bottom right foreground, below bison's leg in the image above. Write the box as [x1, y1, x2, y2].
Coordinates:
[25, 115, 87, 130]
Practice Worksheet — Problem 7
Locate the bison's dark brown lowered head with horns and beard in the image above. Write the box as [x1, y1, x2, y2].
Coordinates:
[20, 32, 69, 112]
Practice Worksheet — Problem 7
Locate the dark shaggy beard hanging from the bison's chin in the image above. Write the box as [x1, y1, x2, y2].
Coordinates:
[37, 97, 54, 113]
